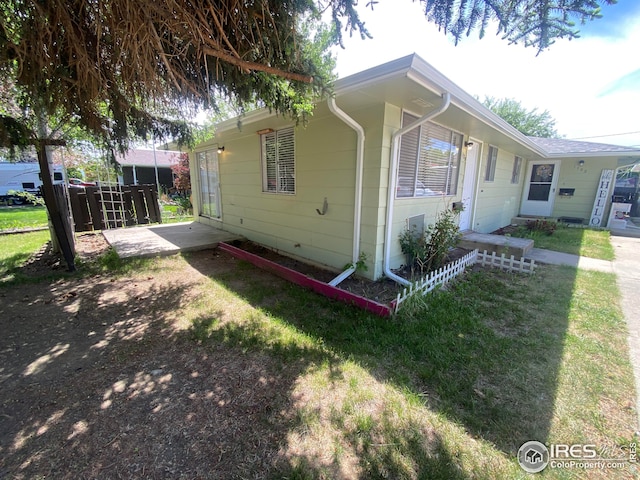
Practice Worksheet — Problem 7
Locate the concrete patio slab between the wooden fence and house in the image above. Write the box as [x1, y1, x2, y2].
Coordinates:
[102, 222, 241, 258]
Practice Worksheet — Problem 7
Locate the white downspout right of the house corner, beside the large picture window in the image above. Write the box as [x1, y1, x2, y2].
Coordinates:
[382, 92, 451, 286]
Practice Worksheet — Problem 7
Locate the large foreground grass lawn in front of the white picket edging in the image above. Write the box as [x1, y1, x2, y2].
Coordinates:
[182, 256, 637, 479]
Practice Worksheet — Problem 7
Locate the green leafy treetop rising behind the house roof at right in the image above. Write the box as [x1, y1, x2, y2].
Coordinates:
[482, 96, 559, 138]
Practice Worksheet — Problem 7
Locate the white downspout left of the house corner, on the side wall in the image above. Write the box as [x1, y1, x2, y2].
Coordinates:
[327, 97, 364, 287]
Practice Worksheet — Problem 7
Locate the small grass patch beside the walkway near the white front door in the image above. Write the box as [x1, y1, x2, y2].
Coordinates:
[512, 223, 614, 260]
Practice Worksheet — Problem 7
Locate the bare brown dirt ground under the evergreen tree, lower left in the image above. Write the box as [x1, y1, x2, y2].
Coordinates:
[0, 235, 312, 479]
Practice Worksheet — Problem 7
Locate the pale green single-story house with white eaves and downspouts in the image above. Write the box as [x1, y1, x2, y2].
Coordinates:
[190, 55, 640, 279]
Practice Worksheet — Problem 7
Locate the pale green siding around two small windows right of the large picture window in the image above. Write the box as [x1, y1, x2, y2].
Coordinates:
[473, 144, 526, 233]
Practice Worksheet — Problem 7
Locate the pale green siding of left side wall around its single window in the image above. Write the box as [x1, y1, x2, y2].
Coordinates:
[198, 106, 390, 276]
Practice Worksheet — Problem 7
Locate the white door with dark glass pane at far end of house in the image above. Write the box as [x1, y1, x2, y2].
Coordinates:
[520, 160, 560, 217]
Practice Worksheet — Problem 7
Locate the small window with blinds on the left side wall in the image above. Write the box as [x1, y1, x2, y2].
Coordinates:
[260, 127, 296, 194]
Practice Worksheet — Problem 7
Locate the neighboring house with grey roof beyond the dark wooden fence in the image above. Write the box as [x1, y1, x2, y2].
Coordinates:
[116, 148, 180, 192]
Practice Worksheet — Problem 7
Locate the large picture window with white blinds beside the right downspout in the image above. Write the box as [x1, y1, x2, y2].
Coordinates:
[396, 112, 462, 197]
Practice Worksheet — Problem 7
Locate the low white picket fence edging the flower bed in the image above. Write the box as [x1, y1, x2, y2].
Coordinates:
[395, 249, 535, 312]
